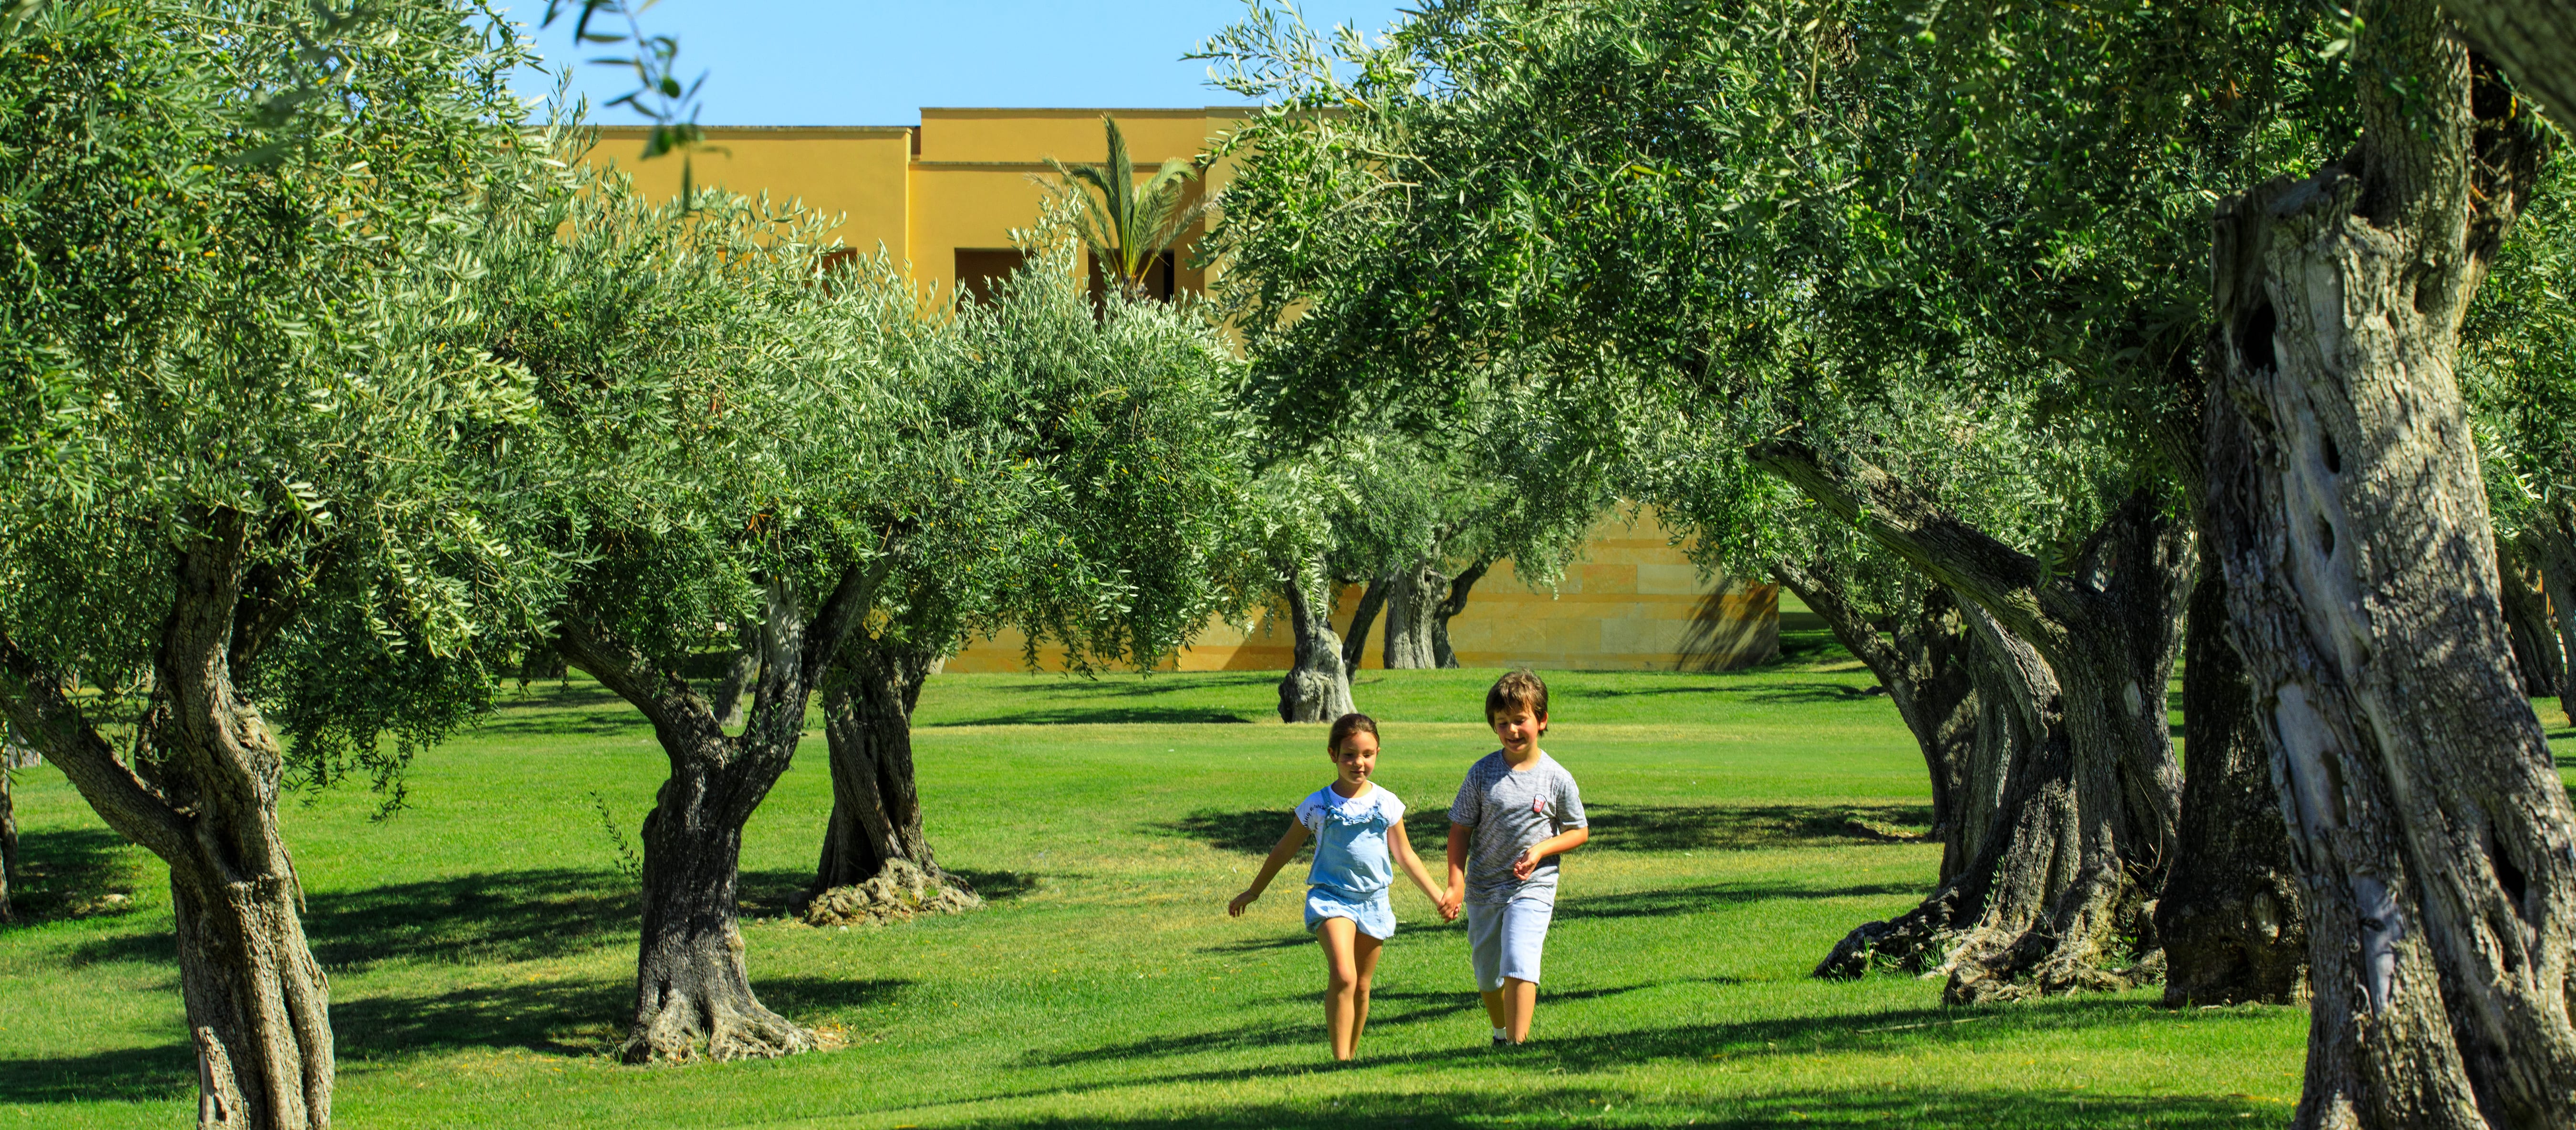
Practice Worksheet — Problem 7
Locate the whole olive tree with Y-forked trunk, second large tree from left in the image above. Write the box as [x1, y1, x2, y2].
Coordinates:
[479, 162, 860, 1060]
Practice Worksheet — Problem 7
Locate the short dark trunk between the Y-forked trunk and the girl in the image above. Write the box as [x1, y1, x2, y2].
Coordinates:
[811, 641, 940, 893]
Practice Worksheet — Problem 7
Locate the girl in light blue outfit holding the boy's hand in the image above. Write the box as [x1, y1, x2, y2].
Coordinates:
[1226, 713, 1458, 1060]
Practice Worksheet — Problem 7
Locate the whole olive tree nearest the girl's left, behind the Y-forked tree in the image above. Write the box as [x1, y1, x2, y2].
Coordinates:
[811, 234, 1270, 911]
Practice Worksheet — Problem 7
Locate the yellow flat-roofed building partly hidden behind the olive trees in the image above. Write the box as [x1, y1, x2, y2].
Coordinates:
[595, 105, 1780, 672]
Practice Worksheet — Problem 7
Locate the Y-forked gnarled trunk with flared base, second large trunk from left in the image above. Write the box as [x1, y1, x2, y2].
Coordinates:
[559, 566, 883, 1063]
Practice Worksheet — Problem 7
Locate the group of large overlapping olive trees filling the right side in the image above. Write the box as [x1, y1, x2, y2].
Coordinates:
[1205, 0, 2576, 1128]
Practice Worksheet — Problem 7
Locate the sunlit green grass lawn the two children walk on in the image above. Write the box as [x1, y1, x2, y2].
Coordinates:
[0, 649, 2555, 1130]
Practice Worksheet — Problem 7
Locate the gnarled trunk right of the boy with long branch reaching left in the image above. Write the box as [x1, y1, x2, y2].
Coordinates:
[1752, 443, 2190, 1001]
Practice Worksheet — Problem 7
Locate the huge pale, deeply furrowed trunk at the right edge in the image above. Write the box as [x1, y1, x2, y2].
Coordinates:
[2208, 13, 2576, 1128]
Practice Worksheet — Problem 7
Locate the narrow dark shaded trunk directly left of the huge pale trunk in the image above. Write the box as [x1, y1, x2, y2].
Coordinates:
[2156, 561, 2308, 1006]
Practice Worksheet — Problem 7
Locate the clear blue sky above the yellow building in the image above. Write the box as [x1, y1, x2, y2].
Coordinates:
[502, 0, 1402, 126]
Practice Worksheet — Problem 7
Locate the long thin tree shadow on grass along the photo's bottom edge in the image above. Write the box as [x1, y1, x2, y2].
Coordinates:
[976, 1086, 2282, 1130]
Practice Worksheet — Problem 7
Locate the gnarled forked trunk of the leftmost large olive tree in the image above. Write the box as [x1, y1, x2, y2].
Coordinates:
[0, 510, 335, 1130]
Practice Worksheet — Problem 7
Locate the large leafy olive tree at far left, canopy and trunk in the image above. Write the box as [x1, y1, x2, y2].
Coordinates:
[0, 2, 549, 1128]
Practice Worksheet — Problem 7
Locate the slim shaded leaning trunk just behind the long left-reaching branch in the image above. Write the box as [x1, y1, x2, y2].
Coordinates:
[1772, 559, 1994, 883]
